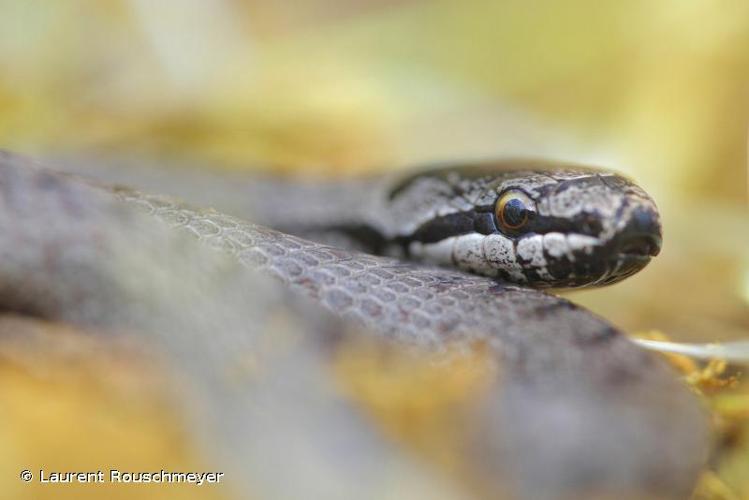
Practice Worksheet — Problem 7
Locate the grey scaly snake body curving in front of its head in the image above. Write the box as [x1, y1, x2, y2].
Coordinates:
[0, 154, 707, 498]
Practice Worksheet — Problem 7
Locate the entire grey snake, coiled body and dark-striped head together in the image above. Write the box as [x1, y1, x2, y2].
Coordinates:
[0, 153, 710, 498]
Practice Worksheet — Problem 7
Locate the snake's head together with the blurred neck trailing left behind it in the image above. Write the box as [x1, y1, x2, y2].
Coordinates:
[232, 159, 662, 288]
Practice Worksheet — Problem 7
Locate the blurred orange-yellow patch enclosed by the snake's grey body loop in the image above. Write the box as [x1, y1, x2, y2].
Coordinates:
[333, 338, 501, 493]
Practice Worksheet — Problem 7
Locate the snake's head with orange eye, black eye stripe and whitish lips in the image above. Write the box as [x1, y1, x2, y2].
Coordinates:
[398, 160, 661, 288]
